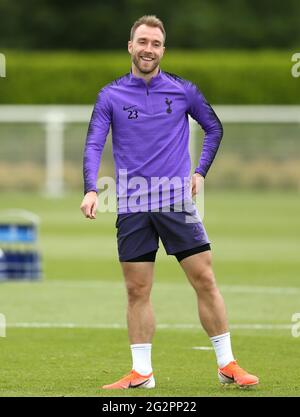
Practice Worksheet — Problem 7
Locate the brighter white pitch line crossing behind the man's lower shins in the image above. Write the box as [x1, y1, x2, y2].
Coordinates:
[6, 322, 292, 330]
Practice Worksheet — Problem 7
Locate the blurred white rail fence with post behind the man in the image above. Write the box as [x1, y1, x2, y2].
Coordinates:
[0, 105, 300, 197]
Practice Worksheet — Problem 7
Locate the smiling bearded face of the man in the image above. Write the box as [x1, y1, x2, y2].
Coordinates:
[128, 25, 165, 74]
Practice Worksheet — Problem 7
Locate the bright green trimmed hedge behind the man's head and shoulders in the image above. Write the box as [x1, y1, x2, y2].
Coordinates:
[0, 50, 300, 104]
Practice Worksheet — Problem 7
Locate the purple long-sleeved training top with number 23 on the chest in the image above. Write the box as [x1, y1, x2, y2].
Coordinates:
[83, 71, 223, 213]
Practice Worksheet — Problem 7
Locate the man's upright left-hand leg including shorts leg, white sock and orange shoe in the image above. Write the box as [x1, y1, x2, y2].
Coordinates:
[103, 212, 159, 389]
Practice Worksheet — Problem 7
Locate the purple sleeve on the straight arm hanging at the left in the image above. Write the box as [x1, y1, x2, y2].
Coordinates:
[83, 90, 111, 193]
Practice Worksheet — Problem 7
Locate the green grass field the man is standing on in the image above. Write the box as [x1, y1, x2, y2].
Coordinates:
[0, 191, 300, 396]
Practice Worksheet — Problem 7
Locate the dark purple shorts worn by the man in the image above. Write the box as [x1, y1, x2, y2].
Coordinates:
[116, 202, 210, 262]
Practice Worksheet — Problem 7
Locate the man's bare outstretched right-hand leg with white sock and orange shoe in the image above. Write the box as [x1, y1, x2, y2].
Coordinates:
[177, 250, 259, 387]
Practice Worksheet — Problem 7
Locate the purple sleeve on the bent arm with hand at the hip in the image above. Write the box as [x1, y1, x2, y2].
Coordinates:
[187, 83, 223, 177]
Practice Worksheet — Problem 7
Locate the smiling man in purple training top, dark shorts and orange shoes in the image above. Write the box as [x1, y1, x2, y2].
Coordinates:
[81, 16, 258, 389]
